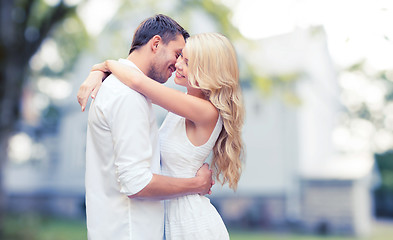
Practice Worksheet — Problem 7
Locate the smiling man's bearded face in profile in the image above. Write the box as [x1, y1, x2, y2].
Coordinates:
[147, 34, 186, 83]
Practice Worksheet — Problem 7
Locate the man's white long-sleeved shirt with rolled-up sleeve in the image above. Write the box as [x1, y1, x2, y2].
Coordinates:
[85, 59, 164, 240]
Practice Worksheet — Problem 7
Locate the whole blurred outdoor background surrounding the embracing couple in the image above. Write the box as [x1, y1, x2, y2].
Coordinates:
[0, 0, 393, 240]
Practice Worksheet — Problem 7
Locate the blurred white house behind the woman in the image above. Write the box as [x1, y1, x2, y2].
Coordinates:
[207, 28, 376, 236]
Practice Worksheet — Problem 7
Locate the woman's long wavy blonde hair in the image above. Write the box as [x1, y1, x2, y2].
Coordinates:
[186, 33, 244, 190]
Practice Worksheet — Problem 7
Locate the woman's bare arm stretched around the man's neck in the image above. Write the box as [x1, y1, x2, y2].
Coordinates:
[98, 60, 218, 124]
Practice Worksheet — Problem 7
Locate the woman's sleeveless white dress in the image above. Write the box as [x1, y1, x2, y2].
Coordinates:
[160, 112, 229, 240]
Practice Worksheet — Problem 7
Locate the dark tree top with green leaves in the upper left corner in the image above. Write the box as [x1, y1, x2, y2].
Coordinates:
[0, 0, 86, 137]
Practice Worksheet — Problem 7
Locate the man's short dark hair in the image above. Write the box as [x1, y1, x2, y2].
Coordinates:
[129, 14, 190, 53]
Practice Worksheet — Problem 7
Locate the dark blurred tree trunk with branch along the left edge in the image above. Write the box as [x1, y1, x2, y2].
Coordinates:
[0, 0, 83, 238]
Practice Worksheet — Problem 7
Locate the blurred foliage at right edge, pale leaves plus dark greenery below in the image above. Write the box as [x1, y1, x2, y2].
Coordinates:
[340, 60, 393, 217]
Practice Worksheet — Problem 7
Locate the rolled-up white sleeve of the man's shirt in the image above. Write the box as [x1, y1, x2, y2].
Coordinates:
[109, 91, 153, 195]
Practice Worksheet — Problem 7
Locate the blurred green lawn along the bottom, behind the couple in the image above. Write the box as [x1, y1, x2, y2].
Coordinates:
[4, 214, 393, 240]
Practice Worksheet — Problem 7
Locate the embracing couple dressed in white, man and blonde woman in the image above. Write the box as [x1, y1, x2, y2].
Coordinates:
[78, 14, 244, 240]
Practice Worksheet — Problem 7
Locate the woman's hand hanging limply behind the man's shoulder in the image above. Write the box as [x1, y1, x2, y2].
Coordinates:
[77, 71, 107, 112]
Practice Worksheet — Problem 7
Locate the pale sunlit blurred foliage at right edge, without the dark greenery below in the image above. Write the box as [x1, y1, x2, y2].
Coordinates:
[339, 61, 393, 154]
